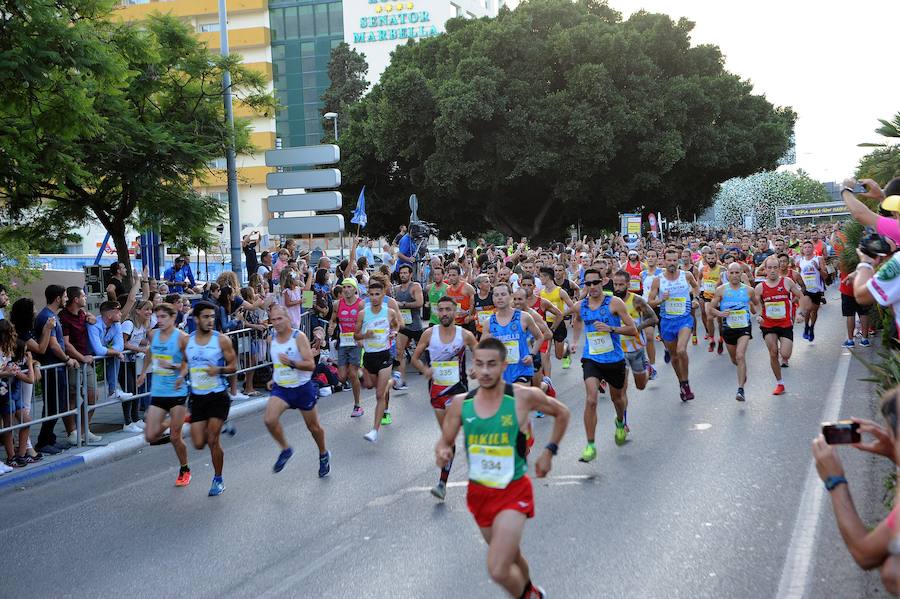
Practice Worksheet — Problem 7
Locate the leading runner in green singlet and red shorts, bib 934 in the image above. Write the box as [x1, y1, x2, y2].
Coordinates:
[435, 338, 569, 599]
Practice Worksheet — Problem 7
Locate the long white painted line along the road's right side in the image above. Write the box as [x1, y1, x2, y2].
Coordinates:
[775, 354, 851, 599]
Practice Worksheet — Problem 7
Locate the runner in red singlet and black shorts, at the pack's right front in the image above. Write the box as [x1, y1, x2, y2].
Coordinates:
[756, 256, 802, 395]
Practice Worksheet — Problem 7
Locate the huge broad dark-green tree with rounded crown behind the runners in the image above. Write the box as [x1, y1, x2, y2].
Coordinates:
[341, 0, 795, 238]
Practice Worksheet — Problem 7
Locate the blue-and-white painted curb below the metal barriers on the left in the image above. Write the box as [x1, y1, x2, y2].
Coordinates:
[0, 396, 269, 493]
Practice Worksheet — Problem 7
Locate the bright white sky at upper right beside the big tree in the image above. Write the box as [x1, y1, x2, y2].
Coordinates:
[609, 0, 900, 181]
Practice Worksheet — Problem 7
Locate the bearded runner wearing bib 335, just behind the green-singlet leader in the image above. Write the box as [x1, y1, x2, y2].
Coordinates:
[411, 296, 475, 501]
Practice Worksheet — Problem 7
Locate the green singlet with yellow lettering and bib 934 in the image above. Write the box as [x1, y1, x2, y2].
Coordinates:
[461, 385, 528, 489]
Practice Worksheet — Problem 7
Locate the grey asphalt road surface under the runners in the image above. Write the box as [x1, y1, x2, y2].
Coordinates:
[0, 299, 885, 598]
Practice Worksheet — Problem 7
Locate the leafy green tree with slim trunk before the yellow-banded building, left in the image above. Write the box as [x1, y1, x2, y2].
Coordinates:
[0, 15, 274, 274]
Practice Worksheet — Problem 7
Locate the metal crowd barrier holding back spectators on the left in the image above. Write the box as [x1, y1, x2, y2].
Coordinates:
[0, 312, 316, 458]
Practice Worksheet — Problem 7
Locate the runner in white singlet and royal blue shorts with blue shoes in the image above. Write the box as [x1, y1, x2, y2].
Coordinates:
[265, 304, 331, 478]
